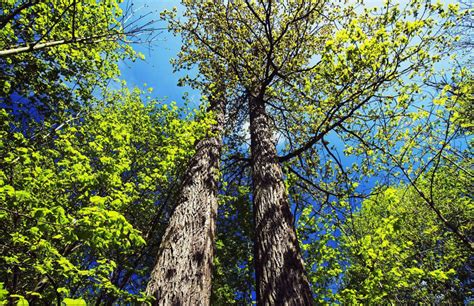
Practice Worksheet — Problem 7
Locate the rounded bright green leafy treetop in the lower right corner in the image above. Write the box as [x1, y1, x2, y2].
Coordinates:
[341, 163, 474, 304]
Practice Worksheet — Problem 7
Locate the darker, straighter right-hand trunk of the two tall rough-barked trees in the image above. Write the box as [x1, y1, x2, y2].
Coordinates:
[249, 96, 313, 305]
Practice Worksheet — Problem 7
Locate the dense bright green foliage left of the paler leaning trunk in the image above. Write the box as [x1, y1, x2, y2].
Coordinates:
[0, 89, 212, 301]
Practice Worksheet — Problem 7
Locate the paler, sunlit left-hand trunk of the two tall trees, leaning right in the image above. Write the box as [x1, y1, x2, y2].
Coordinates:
[146, 99, 225, 305]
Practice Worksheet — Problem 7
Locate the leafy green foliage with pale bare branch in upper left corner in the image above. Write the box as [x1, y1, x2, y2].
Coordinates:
[0, 0, 144, 132]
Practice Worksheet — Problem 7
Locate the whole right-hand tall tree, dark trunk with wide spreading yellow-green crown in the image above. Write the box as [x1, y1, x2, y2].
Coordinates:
[164, 1, 466, 304]
